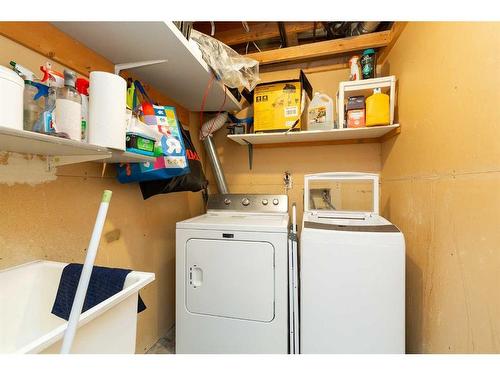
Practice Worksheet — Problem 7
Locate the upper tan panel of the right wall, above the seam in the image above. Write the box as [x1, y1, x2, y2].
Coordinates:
[382, 22, 500, 177]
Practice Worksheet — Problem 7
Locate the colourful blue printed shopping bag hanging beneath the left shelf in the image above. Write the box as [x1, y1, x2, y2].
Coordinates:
[117, 81, 190, 183]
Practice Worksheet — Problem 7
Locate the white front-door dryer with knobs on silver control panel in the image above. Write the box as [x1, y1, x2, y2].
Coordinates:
[176, 194, 290, 353]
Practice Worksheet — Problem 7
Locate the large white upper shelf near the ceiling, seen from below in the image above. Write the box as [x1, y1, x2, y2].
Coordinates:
[53, 22, 241, 111]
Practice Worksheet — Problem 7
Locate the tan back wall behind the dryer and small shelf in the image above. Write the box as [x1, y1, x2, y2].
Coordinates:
[206, 69, 380, 219]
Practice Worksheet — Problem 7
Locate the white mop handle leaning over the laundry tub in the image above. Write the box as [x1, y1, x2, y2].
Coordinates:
[61, 190, 112, 354]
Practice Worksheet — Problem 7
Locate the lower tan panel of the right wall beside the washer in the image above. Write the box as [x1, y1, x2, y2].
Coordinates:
[381, 174, 500, 353]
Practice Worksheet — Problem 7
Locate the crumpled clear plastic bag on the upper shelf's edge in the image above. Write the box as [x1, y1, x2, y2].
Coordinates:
[191, 30, 259, 91]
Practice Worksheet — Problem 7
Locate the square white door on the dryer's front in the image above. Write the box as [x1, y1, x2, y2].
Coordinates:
[185, 239, 274, 322]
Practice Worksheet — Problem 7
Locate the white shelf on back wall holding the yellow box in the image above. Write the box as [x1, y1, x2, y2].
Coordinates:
[227, 124, 400, 146]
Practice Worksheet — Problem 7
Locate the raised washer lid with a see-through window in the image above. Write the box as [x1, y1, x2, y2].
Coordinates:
[304, 172, 379, 219]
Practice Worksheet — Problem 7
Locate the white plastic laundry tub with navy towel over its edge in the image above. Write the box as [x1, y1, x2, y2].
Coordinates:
[0, 260, 155, 354]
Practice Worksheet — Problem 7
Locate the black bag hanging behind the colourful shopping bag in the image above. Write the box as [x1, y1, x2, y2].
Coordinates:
[139, 124, 208, 199]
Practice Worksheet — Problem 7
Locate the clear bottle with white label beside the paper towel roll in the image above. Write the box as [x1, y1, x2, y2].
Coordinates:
[55, 69, 82, 141]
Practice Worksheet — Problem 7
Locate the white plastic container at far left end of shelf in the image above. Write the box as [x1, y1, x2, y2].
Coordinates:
[0, 66, 24, 130]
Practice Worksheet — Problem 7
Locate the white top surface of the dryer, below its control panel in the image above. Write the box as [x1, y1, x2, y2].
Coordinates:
[177, 211, 288, 233]
